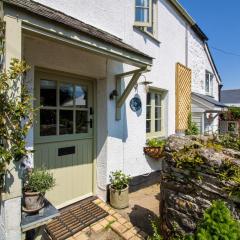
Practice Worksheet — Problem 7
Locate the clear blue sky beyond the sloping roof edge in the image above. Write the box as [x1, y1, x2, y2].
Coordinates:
[179, 0, 240, 89]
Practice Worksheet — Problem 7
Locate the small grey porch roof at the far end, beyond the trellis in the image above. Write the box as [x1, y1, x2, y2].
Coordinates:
[192, 92, 227, 112]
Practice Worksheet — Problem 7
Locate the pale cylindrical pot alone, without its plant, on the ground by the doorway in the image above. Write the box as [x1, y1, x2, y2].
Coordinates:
[110, 185, 129, 209]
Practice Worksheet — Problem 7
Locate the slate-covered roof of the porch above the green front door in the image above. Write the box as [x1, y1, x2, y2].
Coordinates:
[3, 0, 152, 60]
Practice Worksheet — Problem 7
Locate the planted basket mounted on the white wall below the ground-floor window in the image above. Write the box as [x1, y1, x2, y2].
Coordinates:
[143, 138, 166, 159]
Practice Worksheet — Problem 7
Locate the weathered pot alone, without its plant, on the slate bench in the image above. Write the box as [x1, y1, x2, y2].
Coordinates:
[24, 192, 44, 212]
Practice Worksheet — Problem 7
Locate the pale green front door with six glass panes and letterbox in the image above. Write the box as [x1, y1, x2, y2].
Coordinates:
[34, 71, 93, 207]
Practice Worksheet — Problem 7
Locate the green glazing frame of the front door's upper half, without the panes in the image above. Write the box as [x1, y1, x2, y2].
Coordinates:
[34, 71, 94, 143]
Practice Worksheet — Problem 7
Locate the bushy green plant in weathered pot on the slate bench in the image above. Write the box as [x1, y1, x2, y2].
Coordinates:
[23, 169, 55, 212]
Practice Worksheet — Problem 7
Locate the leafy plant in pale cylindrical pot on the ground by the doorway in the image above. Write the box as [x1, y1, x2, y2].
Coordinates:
[110, 171, 131, 209]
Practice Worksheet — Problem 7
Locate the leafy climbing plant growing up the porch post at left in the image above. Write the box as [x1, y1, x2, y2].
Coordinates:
[0, 59, 34, 186]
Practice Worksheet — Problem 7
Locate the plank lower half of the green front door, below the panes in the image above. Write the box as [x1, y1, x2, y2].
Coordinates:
[34, 139, 93, 205]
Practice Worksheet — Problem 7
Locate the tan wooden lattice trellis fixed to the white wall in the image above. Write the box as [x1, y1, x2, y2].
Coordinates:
[176, 63, 192, 132]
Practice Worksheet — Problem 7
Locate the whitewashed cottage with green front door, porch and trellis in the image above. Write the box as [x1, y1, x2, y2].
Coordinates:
[0, 0, 224, 240]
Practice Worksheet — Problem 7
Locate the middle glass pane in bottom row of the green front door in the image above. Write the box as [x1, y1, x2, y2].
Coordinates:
[59, 110, 73, 135]
